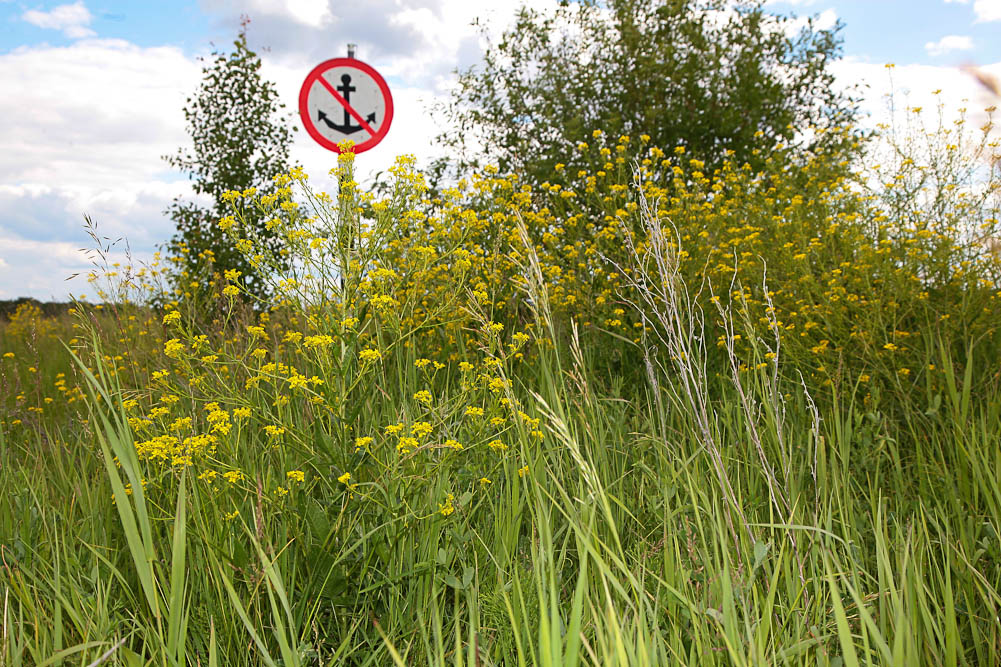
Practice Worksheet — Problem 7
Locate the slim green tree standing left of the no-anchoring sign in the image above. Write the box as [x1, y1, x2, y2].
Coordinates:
[164, 19, 295, 298]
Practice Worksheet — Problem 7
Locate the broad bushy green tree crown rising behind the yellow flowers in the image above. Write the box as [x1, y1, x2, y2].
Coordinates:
[439, 0, 857, 182]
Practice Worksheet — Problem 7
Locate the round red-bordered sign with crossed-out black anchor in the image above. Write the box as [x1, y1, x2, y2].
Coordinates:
[299, 58, 392, 153]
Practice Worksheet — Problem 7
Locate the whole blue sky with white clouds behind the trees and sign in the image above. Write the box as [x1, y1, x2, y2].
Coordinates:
[0, 0, 1001, 300]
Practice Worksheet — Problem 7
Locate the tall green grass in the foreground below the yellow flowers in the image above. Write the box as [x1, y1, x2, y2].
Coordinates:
[0, 250, 1001, 665]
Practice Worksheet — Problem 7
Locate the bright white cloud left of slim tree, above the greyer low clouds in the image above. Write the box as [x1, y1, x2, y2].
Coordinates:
[0, 40, 199, 195]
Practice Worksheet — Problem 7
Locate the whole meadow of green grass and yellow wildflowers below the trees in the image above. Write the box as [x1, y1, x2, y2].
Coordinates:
[0, 91, 1001, 666]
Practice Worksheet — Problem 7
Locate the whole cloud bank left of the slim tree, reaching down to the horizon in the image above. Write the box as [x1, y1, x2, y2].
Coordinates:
[0, 40, 206, 298]
